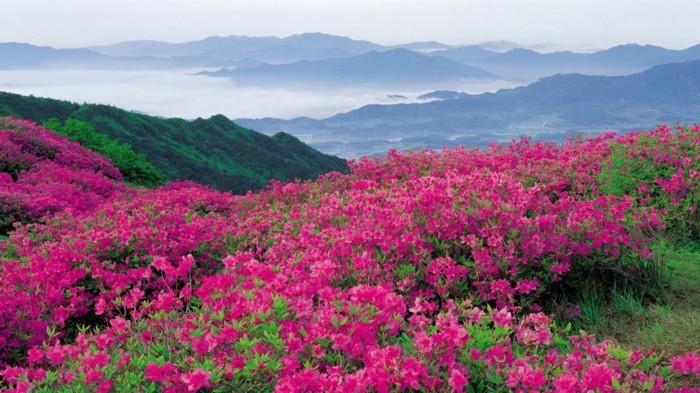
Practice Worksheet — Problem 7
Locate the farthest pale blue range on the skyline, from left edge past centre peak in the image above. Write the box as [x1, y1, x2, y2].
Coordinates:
[0, 33, 394, 69]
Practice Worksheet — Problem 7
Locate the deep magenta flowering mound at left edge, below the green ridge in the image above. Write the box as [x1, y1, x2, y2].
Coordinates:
[0, 118, 123, 234]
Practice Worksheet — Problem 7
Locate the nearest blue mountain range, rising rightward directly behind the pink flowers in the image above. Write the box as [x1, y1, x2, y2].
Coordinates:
[237, 61, 700, 156]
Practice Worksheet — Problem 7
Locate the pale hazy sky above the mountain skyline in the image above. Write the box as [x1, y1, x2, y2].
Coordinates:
[0, 0, 700, 48]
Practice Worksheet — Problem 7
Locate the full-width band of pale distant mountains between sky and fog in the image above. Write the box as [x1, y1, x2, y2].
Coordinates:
[0, 33, 700, 84]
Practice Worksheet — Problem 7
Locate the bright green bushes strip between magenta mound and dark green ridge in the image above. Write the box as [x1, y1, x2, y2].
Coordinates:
[44, 118, 164, 187]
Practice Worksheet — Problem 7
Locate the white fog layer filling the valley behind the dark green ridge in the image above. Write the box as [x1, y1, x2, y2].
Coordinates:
[0, 70, 513, 119]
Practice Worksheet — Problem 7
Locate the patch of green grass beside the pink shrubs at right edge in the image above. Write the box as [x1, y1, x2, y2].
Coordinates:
[576, 243, 700, 356]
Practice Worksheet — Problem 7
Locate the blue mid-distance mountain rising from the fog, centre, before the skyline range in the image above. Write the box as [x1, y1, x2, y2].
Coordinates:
[203, 49, 495, 88]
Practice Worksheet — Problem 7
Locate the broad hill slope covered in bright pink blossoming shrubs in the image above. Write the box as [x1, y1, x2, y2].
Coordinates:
[0, 120, 700, 393]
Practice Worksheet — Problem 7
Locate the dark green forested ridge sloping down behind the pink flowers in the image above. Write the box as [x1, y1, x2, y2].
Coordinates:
[0, 92, 347, 193]
